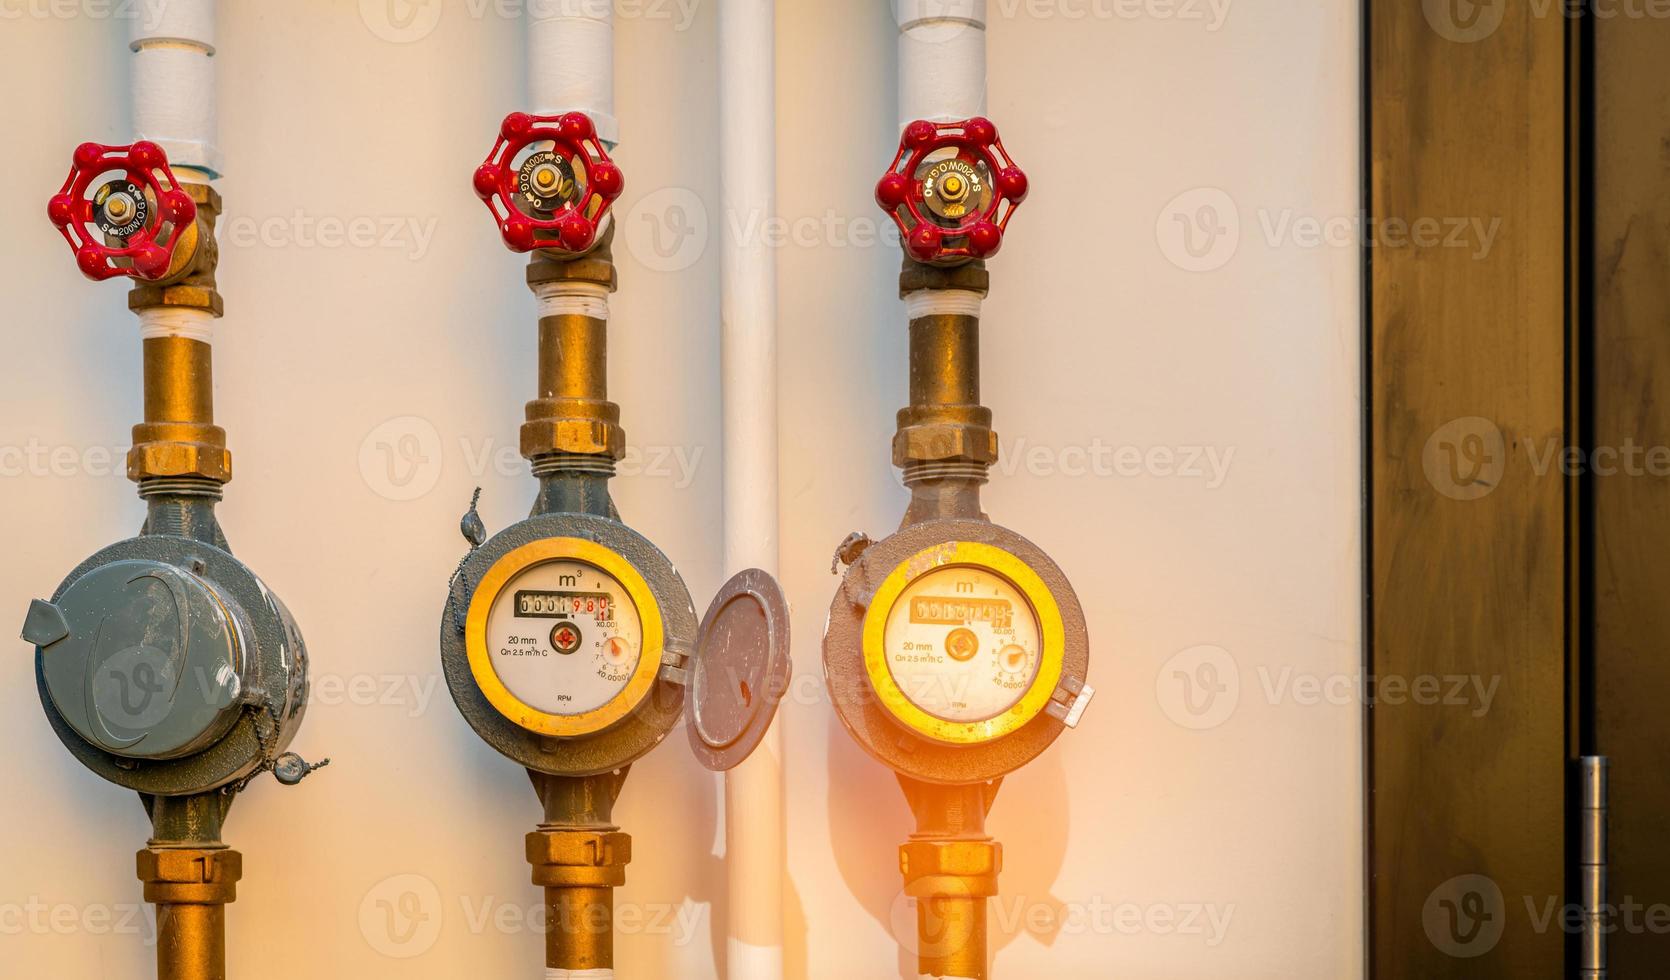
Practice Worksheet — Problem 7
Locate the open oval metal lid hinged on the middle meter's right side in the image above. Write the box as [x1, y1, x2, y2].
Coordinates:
[686, 568, 792, 773]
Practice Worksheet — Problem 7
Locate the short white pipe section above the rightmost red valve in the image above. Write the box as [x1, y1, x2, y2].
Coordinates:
[893, 0, 985, 129]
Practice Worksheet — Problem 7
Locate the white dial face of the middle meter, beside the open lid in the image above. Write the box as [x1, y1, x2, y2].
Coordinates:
[486, 559, 643, 716]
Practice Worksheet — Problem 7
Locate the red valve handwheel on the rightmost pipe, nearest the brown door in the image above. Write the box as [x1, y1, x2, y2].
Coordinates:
[875, 117, 1027, 265]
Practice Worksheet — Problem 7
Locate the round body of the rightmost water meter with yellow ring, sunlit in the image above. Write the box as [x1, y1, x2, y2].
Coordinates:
[823, 518, 1089, 785]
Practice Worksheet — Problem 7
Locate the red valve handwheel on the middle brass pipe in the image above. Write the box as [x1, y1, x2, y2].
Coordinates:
[476, 112, 625, 252]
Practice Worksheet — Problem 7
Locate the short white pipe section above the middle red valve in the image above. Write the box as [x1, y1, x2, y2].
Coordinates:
[526, 0, 620, 147]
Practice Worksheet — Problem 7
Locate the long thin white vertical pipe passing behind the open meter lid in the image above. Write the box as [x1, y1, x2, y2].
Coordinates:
[718, 0, 783, 980]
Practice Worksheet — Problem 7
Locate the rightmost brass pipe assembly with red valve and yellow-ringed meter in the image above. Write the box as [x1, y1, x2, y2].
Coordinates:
[823, 119, 1094, 980]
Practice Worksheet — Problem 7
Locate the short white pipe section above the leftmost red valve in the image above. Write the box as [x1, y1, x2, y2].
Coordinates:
[129, 0, 222, 182]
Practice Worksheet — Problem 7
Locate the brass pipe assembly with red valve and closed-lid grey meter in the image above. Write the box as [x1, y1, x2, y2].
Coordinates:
[22, 142, 324, 980]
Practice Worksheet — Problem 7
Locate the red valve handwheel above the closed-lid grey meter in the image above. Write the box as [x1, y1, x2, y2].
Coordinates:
[47, 140, 197, 280]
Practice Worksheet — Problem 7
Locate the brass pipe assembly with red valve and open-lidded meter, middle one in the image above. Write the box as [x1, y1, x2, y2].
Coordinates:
[441, 112, 790, 977]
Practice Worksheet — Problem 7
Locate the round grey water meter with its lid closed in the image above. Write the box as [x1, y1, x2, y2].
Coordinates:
[23, 534, 307, 796]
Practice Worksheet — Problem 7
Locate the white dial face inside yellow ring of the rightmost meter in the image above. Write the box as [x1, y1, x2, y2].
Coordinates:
[882, 564, 1042, 721]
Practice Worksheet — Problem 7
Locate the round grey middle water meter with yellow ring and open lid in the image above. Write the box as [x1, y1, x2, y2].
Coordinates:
[441, 513, 790, 776]
